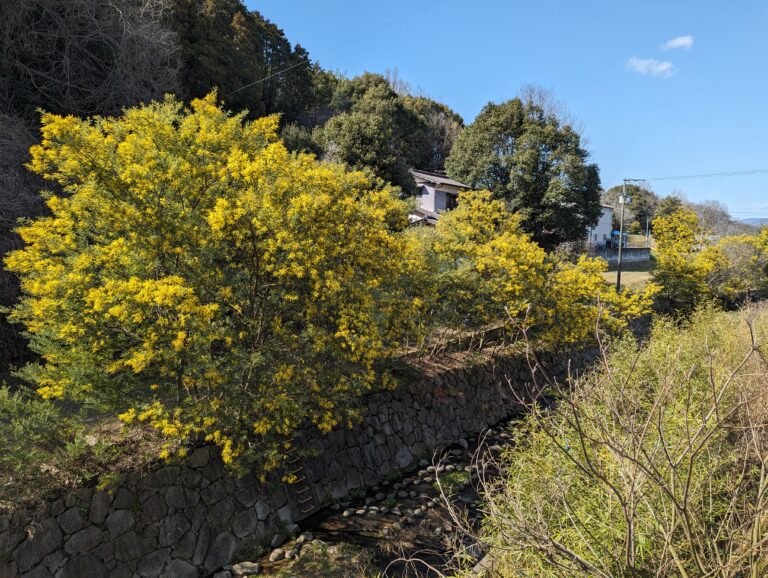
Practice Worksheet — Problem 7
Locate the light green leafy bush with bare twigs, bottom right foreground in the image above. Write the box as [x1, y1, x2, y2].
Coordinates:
[474, 308, 768, 577]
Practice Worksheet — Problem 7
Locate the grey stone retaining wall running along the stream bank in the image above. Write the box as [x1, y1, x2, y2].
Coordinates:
[0, 350, 595, 578]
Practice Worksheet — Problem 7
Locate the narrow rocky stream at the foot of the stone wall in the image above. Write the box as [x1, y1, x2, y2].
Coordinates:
[249, 418, 514, 578]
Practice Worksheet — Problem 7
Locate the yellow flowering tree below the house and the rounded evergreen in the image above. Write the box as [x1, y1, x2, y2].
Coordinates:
[431, 191, 657, 343]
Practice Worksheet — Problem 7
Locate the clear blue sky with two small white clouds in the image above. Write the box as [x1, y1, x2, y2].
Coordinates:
[246, 0, 768, 217]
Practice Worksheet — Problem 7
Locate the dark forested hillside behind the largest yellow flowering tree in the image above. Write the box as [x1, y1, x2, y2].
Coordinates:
[0, 0, 463, 367]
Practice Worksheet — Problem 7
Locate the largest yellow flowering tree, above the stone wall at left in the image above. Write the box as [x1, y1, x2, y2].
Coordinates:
[6, 95, 423, 466]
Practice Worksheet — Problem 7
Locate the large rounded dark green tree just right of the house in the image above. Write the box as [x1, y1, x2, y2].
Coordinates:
[446, 98, 601, 249]
